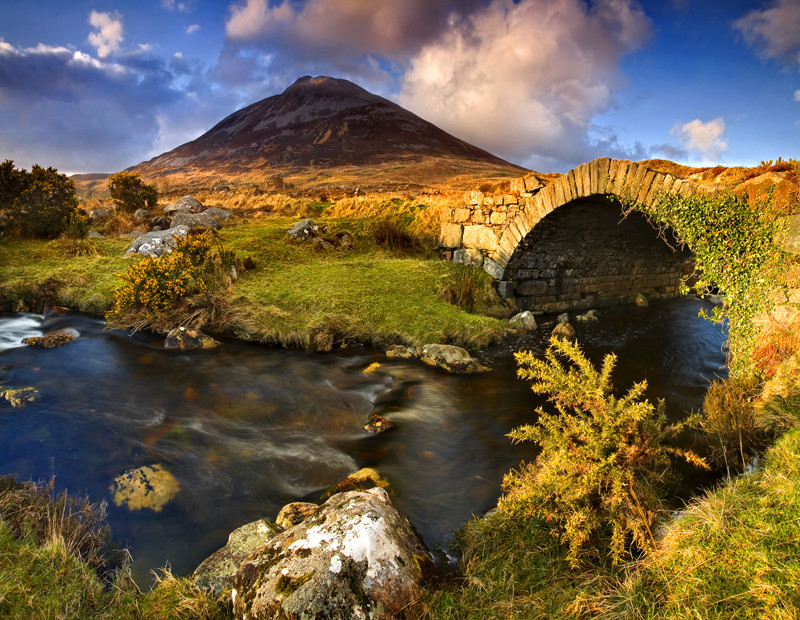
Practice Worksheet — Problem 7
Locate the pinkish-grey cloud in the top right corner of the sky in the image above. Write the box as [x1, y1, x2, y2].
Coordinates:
[733, 0, 800, 65]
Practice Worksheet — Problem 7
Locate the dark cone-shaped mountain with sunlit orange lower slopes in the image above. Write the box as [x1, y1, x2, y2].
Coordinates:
[132, 76, 526, 193]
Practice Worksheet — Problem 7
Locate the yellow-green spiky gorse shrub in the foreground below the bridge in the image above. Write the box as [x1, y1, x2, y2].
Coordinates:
[498, 339, 706, 565]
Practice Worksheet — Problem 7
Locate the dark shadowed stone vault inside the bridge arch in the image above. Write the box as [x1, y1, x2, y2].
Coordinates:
[502, 195, 693, 312]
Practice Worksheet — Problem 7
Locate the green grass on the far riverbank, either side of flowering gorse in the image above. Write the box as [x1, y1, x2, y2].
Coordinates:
[0, 217, 506, 349]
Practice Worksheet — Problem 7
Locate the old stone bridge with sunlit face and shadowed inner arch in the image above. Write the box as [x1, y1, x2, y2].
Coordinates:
[440, 157, 694, 312]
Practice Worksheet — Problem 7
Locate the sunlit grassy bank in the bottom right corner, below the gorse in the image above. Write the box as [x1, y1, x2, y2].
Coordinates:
[427, 430, 800, 620]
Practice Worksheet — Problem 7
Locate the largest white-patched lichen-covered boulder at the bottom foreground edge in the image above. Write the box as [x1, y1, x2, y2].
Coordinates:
[231, 488, 432, 620]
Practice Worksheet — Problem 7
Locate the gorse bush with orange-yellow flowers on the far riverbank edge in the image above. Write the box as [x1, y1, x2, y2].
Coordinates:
[106, 233, 235, 326]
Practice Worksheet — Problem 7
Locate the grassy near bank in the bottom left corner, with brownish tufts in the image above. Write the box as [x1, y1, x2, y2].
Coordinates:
[0, 476, 230, 620]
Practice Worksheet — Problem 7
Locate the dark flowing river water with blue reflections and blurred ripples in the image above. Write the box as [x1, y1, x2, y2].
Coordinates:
[0, 299, 725, 583]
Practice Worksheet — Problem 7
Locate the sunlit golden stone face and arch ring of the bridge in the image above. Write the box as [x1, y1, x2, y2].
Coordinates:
[440, 157, 693, 308]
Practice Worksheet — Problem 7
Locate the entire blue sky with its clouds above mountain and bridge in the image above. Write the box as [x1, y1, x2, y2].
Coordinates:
[0, 0, 800, 172]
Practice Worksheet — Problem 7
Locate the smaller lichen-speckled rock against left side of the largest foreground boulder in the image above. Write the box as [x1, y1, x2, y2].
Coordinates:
[192, 519, 283, 597]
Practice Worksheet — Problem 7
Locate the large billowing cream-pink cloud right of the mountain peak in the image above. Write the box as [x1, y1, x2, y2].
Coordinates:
[399, 0, 650, 169]
